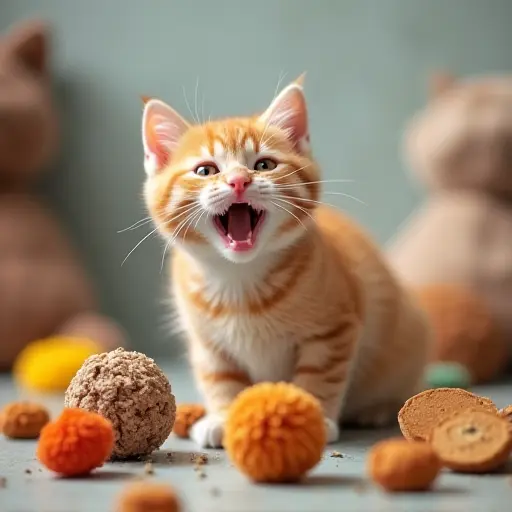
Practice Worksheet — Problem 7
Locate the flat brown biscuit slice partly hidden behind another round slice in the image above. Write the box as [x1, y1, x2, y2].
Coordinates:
[398, 388, 498, 441]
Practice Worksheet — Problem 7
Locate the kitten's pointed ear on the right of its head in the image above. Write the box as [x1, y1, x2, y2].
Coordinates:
[260, 74, 309, 152]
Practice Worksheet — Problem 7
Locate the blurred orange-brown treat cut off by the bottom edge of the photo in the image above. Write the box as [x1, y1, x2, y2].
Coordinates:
[116, 482, 181, 512]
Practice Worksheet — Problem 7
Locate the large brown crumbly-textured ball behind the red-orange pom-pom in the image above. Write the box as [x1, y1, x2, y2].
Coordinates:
[64, 348, 176, 459]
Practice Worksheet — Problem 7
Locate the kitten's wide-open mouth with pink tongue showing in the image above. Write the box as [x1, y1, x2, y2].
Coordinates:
[213, 203, 265, 252]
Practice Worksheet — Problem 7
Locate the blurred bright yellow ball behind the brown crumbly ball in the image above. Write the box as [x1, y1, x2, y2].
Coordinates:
[13, 336, 101, 392]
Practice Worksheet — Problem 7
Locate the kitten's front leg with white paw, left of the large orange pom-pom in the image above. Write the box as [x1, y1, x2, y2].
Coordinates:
[190, 337, 251, 448]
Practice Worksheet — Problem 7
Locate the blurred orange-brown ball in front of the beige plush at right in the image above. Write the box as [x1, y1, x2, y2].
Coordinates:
[417, 284, 508, 384]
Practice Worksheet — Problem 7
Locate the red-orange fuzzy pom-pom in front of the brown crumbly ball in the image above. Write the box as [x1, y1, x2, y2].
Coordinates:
[37, 408, 114, 476]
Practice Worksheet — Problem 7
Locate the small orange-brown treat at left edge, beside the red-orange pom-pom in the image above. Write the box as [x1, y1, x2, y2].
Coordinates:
[0, 402, 50, 439]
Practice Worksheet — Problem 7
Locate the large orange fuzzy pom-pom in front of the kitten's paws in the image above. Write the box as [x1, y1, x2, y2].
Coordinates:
[223, 382, 327, 483]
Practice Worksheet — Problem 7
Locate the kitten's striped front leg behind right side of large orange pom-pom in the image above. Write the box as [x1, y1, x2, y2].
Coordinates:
[293, 319, 360, 443]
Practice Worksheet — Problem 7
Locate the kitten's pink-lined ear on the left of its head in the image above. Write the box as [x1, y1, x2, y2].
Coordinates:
[142, 98, 189, 175]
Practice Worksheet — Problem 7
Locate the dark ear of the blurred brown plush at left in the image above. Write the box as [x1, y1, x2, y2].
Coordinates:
[7, 21, 48, 74]
